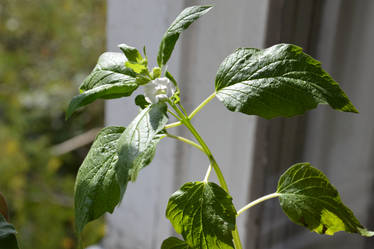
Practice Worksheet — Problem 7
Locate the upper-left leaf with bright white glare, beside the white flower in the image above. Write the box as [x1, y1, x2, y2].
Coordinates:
[66, 52, 138, 118]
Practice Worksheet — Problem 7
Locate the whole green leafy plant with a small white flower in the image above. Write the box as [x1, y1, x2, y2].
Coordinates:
[55, 6, 374, 249]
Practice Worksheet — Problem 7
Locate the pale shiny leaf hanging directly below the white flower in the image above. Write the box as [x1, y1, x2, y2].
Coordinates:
[118, 103, 168, 181]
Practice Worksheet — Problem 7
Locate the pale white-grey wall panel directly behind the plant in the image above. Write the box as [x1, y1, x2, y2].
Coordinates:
[104, 0, 268, 249]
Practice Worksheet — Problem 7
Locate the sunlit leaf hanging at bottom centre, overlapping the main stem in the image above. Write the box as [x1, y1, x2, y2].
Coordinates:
[166, 182, 236, 249]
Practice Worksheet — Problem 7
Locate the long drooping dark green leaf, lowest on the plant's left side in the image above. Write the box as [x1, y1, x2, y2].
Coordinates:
[74, 126, 128, 233]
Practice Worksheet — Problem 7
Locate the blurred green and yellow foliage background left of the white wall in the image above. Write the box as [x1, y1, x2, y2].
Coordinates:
[0, 0, 106, 249]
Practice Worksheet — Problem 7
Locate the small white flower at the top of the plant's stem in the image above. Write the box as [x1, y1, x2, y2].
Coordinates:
[144, 77, 175, 104]
